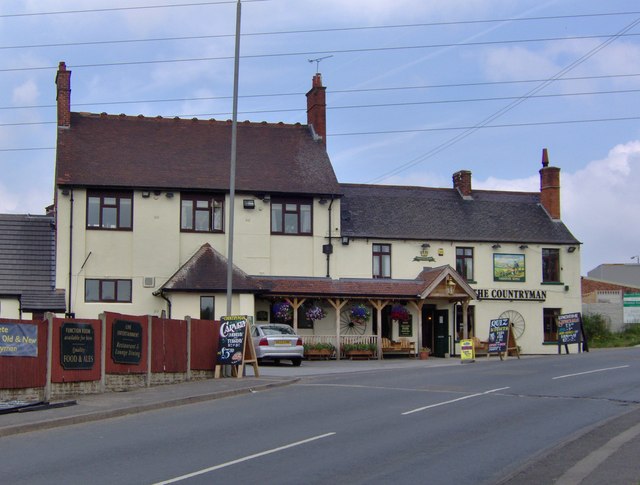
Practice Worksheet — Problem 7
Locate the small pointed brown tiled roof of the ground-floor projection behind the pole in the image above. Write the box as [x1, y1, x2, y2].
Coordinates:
[158, 243, 261, 293]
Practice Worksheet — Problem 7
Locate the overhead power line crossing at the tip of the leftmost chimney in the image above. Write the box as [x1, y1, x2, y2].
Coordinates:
[0, 33, 640, 72]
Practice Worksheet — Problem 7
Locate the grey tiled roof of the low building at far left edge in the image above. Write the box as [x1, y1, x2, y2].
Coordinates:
[0, 214, 66, 313]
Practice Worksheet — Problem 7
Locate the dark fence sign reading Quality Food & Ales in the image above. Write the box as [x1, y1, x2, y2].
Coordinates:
[60, 323, 95, 370]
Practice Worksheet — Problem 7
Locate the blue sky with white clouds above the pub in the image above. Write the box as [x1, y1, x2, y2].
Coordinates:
[0, 0, 640, 275]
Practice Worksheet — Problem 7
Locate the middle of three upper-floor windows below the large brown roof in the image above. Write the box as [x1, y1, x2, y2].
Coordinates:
[180, 194, 223, 232]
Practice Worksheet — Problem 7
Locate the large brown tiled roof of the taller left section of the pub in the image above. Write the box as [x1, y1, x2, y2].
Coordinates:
[56, 113, 340, 195]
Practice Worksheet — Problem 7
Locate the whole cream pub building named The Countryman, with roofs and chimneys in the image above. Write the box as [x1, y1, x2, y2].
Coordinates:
[38, 62, 581, 358]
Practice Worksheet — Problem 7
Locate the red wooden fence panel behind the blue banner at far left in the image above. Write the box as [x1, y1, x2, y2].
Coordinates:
[0, 318, 48, 389]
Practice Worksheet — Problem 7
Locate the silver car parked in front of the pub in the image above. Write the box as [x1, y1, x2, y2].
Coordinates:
[251, 323, 304, 366]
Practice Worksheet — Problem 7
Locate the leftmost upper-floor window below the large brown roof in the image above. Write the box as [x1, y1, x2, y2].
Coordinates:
[87, 191, 133, 231]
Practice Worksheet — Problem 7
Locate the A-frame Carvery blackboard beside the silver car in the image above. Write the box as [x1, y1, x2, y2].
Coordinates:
[214, 315, 260, 379]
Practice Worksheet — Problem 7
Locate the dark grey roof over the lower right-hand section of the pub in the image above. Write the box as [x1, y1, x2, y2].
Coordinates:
[340, 184, 579, 244]
